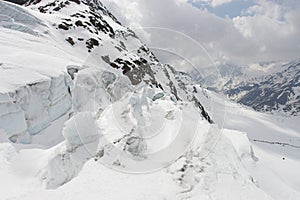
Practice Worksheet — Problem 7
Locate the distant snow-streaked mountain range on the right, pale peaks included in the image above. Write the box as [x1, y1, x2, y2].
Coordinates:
[191, 59, 300, 115]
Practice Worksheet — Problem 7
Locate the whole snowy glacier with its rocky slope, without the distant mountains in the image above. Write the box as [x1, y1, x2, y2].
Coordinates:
[0, 0, 300, 200]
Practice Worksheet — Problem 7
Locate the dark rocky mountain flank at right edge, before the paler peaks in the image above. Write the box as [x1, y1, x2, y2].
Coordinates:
[225, 60, 300, 115]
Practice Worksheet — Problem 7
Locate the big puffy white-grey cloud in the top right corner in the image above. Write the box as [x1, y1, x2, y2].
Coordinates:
[232, 1, 300, 60]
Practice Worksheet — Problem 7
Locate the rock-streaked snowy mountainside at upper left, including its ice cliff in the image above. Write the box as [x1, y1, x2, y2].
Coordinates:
[0, 1, 211, 143]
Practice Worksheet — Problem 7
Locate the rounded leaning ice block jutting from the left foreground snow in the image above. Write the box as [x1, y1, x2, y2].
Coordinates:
[41, 112, 100, 189]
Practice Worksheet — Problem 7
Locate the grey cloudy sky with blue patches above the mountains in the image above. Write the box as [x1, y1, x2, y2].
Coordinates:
[103, 0, 300, 68]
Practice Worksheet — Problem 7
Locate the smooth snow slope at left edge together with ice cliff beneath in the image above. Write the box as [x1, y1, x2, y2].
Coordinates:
[0, 2, 82, 143]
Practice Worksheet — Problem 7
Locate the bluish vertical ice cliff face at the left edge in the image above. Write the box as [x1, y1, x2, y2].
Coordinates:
[0, 68, 71, 143]
